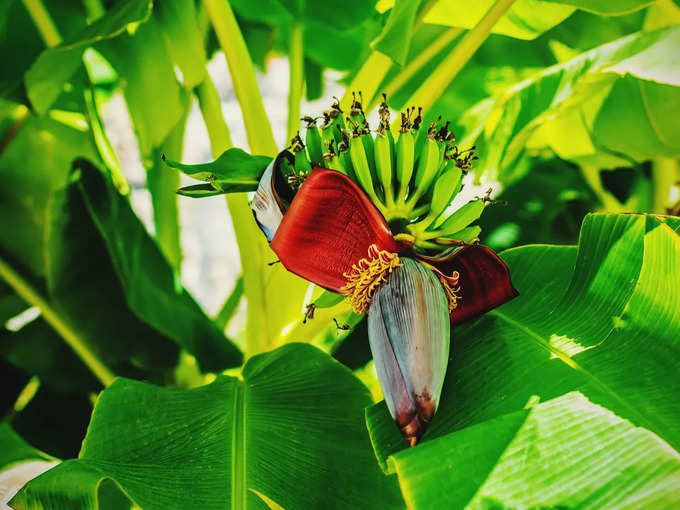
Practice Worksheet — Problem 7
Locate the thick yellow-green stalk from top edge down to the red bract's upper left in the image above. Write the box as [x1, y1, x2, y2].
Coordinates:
[203, 0, 277, 156]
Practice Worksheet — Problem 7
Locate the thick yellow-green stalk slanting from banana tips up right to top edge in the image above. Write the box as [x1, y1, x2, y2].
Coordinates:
[392, 0, 515, 124]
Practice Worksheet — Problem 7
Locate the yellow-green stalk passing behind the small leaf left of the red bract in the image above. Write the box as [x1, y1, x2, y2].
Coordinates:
[196, 72, 274, 356]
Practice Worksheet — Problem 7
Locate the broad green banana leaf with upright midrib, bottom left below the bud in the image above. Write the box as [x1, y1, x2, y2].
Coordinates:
[11, 344, 400, 510]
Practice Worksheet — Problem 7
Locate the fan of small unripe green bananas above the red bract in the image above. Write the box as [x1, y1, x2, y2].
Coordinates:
[286, 93, 488, 252]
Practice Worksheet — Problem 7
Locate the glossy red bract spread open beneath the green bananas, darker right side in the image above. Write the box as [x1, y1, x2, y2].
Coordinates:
[271, 167, 517, 324]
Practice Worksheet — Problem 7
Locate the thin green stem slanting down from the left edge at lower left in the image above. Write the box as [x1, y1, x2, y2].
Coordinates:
[0, 259, 116, 386]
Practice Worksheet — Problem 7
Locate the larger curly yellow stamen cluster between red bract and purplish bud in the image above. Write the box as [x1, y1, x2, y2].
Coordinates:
[341, 244, 401, 313]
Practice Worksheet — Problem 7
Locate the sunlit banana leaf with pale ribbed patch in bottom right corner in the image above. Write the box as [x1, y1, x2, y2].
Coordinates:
[390, 392, 680, 509]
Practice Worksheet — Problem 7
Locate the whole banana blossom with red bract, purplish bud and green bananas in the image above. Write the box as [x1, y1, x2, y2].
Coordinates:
[167, 94, 517, 446]
